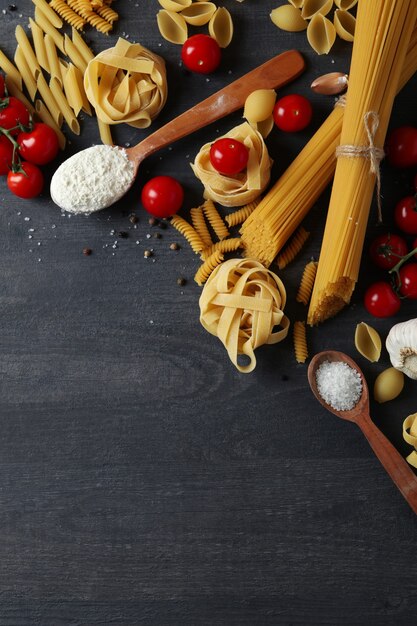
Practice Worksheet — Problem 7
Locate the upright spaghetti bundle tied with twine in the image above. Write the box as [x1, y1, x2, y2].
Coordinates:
[308, 0, 417, 325]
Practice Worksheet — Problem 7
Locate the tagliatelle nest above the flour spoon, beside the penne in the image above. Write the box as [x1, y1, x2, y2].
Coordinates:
[84, 38, 168, 128]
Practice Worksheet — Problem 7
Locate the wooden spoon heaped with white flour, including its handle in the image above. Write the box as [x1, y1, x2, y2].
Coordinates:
[51, 50, 305, 214]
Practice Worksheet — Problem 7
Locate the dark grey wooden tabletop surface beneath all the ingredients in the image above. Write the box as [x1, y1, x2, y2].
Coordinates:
[0, 0, 417, 626]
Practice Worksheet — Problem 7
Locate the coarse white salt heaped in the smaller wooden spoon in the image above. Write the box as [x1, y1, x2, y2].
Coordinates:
[316, 361, 362, 411]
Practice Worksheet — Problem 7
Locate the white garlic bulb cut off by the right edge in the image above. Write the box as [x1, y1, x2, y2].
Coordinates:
[385, 319, 417, 380]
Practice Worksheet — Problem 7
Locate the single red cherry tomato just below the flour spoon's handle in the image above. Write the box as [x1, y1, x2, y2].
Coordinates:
[141, 176, 184, 217]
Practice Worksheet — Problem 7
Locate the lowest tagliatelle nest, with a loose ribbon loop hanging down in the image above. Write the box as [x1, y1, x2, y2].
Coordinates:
[199, 259, 289, 373]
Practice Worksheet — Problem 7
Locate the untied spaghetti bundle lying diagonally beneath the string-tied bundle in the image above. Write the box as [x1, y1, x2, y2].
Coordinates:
[241, 29, 417, 267]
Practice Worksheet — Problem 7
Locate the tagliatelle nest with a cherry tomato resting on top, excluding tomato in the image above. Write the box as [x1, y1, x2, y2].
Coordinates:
[191, 122, 272, 207]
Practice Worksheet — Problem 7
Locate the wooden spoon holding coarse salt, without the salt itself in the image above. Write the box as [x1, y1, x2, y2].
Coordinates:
[307, 350, 417, 513]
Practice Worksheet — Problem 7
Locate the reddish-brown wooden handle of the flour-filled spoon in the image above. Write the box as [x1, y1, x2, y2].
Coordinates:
[127, 50, 305, 165]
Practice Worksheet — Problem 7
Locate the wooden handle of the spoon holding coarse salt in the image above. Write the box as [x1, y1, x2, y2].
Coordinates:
[357, 418, 417, 513]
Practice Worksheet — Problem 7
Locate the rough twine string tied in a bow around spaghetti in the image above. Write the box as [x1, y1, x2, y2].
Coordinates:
[336, 111, 385, 222]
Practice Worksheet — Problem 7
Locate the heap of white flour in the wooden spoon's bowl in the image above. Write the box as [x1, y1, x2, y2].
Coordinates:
[51, 146, 134, 214]
